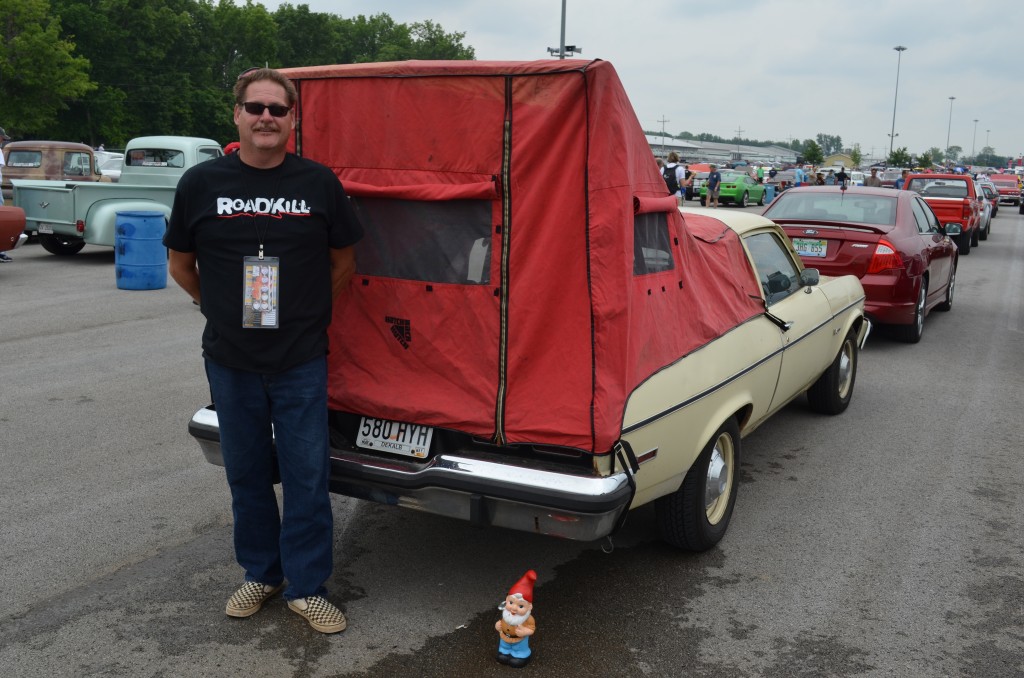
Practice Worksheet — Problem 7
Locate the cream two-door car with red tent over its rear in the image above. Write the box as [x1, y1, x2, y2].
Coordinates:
[189, 59, 869, 550]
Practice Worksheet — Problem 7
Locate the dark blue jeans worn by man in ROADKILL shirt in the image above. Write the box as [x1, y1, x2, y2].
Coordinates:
[206, 357, 334, 600]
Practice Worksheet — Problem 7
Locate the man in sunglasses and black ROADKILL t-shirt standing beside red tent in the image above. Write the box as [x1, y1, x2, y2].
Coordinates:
[164, 69, 362, 633]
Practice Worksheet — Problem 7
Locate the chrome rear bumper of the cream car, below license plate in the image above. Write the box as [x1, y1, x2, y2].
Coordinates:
[188, 408, 633, 541]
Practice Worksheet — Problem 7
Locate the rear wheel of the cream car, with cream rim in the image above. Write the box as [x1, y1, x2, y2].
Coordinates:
[654, 417, 740, 551]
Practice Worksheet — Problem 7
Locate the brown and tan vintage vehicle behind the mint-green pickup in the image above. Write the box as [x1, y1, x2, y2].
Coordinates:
[2, 141, 111, 201]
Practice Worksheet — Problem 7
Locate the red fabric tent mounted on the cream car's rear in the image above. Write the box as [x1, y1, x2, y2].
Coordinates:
[283, 59, 763, 454]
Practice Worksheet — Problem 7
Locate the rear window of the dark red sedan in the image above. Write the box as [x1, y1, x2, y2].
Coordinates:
[765, 192, 896, 226]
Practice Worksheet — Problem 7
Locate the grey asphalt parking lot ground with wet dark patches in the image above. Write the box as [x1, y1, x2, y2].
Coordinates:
[0, 208, 1024, 678]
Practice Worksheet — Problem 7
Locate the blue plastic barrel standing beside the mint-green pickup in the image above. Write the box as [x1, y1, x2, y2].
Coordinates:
[114, 212, 167, 290]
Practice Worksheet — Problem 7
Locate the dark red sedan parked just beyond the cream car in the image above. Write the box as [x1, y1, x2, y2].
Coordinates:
[764, 186, 958, 343]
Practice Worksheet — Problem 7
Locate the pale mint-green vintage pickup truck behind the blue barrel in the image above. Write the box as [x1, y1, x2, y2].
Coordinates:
[11, 136, 223, 255]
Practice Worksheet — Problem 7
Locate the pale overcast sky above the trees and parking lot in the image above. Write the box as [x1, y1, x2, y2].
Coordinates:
[247, 0, 1024, 162]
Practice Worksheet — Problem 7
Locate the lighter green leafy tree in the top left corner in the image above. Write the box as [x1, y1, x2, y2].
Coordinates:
[0, 0, 95, 136]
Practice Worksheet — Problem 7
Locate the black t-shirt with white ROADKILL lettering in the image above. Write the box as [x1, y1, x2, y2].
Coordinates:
[164, 154, 362, 374]
